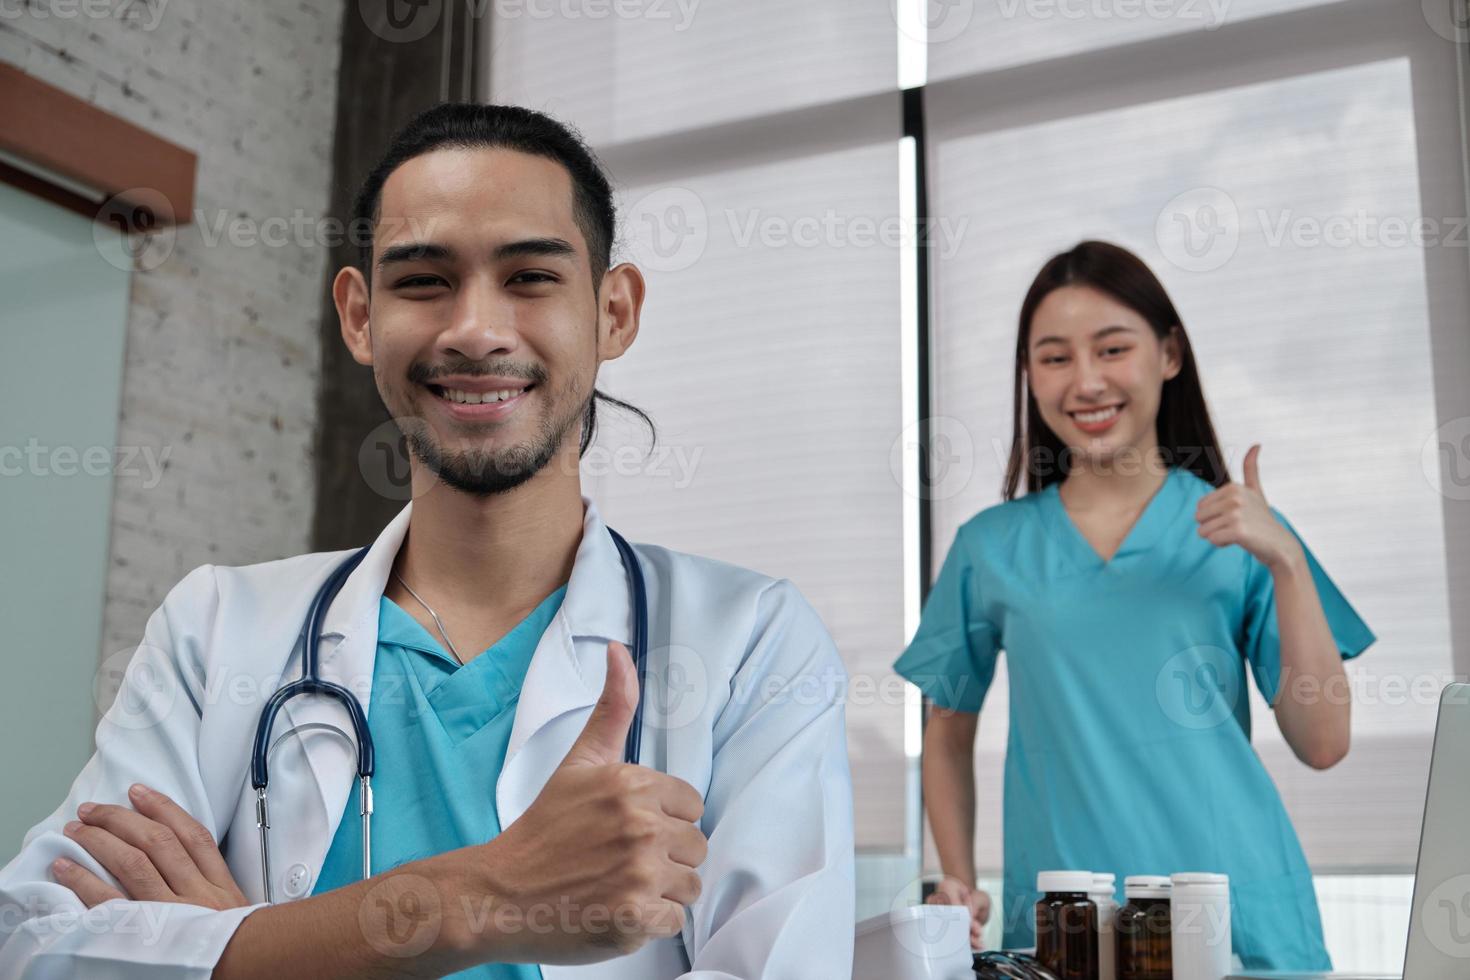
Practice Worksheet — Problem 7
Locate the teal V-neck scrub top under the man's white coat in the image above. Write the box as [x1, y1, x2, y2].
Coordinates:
[312, 586, 566, 980]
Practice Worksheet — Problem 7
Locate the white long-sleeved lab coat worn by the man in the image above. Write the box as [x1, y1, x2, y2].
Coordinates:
[0, 497, 854, 980]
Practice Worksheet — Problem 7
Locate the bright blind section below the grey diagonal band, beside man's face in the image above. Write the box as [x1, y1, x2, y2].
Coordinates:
[584, 132, 904, 846]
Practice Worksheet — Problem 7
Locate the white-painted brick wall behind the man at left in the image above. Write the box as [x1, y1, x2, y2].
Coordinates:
[0, 0, 344, 687]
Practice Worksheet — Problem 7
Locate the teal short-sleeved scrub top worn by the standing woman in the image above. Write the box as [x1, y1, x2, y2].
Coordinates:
[894, 469, 1374, 970]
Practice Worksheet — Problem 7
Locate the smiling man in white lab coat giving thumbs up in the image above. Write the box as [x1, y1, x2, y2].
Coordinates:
[0, 106, 854, 980]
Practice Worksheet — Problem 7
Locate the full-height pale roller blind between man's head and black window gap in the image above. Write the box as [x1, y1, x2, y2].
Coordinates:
[487, 0, 913, 846]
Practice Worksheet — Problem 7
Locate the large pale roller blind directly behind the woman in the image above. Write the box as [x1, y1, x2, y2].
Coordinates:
[929, 4, 1470, 870]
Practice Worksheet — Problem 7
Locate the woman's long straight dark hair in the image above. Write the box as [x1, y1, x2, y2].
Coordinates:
[1003, 241, 1230, 500]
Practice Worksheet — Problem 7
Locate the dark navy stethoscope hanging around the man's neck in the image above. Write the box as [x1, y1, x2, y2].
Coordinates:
[250, 527, 648, 902]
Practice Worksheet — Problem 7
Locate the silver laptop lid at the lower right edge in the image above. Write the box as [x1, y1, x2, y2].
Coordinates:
[1232, 685, 1470, 980]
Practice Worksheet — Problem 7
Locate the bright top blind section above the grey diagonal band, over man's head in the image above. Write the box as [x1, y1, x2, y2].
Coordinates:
[488, 0, 898, 145]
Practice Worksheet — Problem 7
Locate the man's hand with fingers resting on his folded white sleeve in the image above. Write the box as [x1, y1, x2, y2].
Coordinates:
[51, 783, 250, 909]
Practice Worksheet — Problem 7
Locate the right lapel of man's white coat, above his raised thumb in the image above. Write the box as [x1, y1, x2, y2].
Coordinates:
[495, 497, 632, 827]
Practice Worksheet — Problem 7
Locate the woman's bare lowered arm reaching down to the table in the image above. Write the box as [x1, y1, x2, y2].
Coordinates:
[923, 705, 991, 946]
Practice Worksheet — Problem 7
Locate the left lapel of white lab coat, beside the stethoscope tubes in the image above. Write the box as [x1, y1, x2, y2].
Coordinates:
[270, 504, 412, 899]
